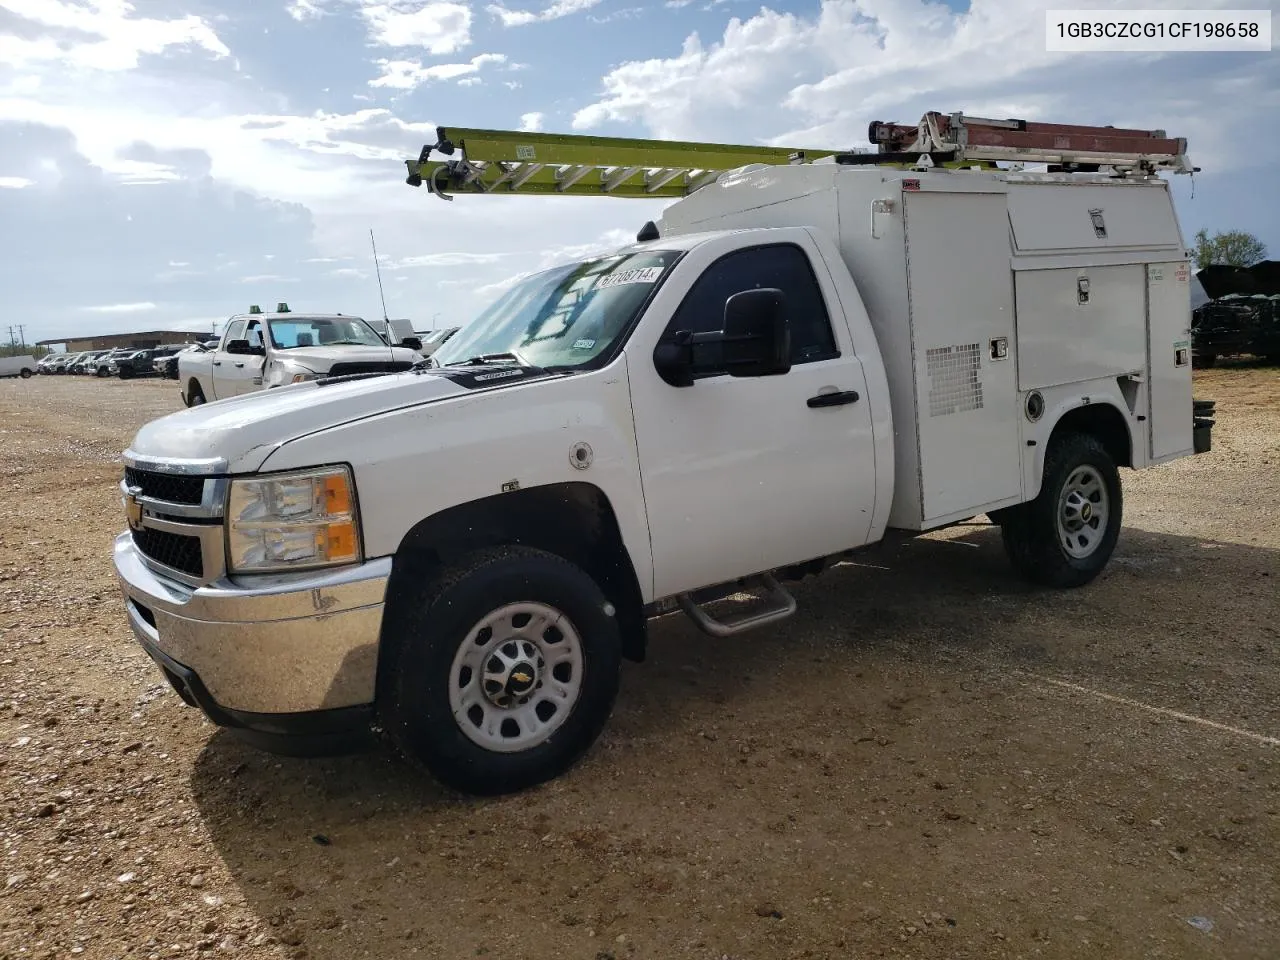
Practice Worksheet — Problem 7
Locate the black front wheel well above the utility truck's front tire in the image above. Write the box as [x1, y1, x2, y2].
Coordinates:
[379, 483, 646, 662]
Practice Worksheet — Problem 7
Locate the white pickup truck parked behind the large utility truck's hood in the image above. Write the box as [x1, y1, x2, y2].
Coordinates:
[178, 303, 422, 407]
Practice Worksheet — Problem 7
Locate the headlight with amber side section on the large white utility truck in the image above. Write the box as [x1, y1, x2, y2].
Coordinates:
[227, 467, 362, 573]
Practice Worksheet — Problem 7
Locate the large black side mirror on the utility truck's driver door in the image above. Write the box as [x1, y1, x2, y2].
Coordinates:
[653, 287, 791, 387]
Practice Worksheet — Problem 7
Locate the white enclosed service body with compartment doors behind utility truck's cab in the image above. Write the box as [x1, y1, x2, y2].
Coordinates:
[659, 163, 1192, 530]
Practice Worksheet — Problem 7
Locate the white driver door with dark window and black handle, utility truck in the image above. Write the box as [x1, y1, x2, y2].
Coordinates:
[627, 232, 876, 596]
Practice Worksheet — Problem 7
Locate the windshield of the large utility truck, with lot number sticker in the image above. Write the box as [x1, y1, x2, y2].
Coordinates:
[433, 251, 680, 370]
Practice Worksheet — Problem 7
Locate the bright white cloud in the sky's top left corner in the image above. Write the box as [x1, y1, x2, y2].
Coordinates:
[0, 0, 230, 70]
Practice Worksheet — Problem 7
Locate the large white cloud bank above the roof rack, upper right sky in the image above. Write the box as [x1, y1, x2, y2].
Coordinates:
[572, 0, 1280, 180]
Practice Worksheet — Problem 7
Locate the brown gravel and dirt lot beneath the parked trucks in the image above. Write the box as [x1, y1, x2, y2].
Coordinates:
[0, 369, 1280, 960]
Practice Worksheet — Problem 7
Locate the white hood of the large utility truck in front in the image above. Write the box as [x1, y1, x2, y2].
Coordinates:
[129, 368, 476, 472]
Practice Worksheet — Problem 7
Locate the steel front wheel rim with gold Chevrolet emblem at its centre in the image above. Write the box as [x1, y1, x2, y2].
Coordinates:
[449, 602, 582, 753]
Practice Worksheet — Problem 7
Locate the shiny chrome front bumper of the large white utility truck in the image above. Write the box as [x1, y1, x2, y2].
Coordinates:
[114, 532, 392, 727]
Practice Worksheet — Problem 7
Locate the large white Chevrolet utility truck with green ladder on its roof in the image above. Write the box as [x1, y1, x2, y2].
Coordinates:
[114, 114, 1207, 792]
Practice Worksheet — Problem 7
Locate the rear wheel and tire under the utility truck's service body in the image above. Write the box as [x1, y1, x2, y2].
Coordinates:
[1001, 434, 1124, 588]
